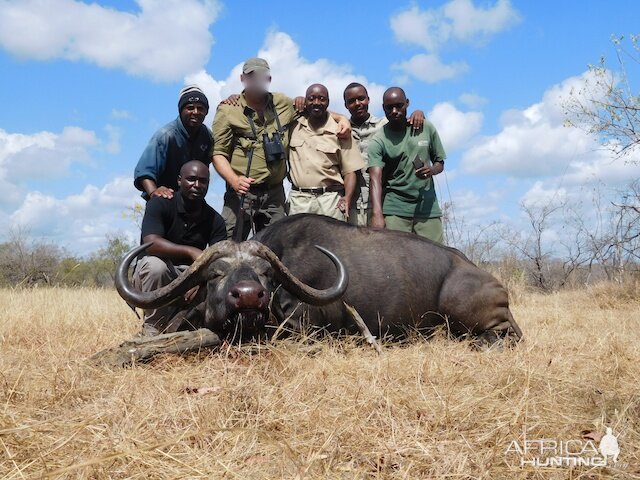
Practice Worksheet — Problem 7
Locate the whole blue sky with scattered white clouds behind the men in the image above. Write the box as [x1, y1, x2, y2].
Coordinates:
[0, 0, 640, 255]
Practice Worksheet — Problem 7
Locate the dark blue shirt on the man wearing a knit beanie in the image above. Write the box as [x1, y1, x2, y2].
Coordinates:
[133, 116, 213, 200]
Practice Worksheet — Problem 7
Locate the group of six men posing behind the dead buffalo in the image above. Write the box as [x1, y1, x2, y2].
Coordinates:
[133, 58, 446, 334]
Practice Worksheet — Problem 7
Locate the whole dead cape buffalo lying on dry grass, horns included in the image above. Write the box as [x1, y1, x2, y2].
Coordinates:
[116, 214, 522, 343]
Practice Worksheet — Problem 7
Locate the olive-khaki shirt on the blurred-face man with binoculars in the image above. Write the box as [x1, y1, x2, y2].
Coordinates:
[212, 92, 298, 185]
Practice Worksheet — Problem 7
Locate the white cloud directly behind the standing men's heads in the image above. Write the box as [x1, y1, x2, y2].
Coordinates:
[184, 31, 385, 116]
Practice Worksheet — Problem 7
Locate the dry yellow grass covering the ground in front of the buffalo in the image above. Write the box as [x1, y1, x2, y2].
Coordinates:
[0, 285, 640, 479]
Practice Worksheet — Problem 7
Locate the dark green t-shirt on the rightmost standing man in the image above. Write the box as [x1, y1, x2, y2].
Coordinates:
[368, 120, 447, 218]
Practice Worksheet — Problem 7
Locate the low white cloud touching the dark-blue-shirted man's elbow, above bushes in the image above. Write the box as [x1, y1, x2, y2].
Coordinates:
[9, 177, 140, 254]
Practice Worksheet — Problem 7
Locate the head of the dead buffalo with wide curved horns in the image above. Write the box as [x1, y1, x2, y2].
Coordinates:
[115, 240, 349, 340]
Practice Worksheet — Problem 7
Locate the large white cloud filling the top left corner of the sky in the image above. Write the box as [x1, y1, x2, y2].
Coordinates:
[0, 0, 219, 81]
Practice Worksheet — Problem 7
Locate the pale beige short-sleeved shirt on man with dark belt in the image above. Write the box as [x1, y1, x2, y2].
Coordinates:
[289, 115, 365, 188]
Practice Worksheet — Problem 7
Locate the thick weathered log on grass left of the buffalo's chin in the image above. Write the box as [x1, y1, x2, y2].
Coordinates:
[89, 328, 222, 367]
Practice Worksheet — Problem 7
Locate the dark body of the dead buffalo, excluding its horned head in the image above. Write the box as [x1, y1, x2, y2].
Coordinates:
[254, 215, 522, 344]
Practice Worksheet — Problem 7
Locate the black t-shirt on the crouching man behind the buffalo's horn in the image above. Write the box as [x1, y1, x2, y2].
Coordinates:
[141, 191, 227, 265]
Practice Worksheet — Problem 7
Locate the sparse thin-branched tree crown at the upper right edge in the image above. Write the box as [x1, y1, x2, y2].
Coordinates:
[563, 35, 640, 157]
